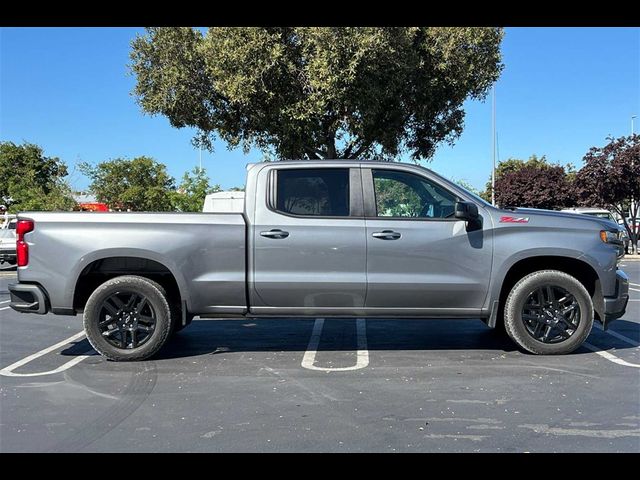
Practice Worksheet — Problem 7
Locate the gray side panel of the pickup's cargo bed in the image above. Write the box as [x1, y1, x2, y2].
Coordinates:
[18, 212, 247, 314]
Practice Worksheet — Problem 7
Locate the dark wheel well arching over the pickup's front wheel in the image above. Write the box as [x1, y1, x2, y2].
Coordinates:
[496, 256, 599, 322]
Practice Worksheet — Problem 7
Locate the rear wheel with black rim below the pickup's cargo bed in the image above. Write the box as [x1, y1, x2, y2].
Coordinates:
[83, 275, 172, 362]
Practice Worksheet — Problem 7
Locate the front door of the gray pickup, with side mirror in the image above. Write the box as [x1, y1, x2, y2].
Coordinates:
[362, 167, 492, 316]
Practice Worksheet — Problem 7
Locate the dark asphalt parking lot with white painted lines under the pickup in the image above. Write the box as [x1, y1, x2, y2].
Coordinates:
[0, 261, 640, 452]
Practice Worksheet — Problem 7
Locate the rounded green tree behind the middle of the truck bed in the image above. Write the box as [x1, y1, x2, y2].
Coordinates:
[80, 156, 174, 212]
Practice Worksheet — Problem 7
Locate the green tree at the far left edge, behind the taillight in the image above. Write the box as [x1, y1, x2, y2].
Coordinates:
[0, 142, 75, 213]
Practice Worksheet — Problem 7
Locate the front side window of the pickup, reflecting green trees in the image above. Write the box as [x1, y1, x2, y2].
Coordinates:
[372, 169, 456, 218]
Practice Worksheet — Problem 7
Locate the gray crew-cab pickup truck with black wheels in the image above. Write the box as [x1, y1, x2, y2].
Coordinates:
[9, 161, 629, 360]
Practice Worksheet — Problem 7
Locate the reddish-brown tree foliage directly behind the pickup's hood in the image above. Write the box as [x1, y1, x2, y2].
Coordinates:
[488, 155, 575, 210]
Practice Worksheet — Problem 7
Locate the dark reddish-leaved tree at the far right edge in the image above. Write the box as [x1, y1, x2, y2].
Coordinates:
[574, 135, 640, 244]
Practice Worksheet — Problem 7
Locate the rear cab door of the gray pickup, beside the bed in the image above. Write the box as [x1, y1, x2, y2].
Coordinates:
[252, 164, 366, 314]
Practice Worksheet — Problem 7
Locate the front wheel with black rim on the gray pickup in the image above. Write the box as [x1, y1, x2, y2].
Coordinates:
[504, 270, 594, 355]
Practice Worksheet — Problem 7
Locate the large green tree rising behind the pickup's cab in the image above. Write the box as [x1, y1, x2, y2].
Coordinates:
[130, 27, 503, 159]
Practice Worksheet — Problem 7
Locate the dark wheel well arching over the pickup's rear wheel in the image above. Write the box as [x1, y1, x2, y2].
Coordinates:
[73, 257, 181, 311]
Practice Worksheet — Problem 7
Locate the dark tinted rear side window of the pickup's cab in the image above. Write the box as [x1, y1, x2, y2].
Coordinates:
[276, 168, 349, 217]
